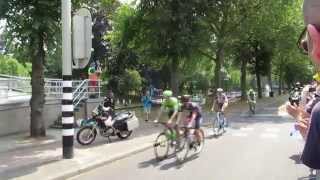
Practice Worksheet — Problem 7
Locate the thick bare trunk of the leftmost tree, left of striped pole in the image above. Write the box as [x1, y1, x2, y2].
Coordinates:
[30, 33, 46, 137]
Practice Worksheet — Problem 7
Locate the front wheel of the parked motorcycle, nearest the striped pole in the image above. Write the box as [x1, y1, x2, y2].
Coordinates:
[77, 127, 97, 145]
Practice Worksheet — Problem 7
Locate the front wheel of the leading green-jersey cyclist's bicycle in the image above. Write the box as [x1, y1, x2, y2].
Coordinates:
[153, 132, 170, 161]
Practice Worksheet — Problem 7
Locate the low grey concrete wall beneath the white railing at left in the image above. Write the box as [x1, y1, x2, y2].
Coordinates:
[0, 100, 99, 136]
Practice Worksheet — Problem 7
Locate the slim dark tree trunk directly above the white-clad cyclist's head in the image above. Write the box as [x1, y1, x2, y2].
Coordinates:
[214, 46, 224, 89]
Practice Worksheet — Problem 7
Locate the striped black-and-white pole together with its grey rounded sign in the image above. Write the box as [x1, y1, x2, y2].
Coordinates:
[61, 0, 92, 159]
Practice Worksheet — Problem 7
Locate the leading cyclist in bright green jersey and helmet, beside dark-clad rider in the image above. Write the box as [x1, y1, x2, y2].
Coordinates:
[154, 90, 179, 124]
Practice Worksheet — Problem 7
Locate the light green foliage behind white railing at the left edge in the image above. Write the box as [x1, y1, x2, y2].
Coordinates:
[0, 55, 31, 77]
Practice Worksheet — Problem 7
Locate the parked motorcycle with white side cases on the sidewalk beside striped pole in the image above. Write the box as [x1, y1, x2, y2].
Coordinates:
[77, 104, 139, 145]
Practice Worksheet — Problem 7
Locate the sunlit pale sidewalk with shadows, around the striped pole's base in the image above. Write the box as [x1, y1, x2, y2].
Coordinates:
[0, 131, 156, 180]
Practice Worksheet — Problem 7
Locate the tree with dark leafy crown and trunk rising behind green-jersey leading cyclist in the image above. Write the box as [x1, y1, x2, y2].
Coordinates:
[126, 0, 203, 95]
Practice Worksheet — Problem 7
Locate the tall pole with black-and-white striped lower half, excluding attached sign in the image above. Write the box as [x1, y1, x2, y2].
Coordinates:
[61, 0, 74, 159]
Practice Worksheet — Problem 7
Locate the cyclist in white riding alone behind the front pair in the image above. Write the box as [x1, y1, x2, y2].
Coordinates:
[211, 88, 229, 126]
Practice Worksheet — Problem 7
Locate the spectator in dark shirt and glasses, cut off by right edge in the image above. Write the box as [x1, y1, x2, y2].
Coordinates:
[287, 0, 320, 170]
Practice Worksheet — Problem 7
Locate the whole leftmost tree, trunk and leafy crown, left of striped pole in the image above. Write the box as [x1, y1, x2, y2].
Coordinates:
[0, 0, 61, 137]
